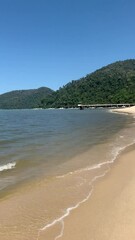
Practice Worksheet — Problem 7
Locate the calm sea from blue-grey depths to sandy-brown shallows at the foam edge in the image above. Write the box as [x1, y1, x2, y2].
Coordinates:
[0, 109, 135, 240]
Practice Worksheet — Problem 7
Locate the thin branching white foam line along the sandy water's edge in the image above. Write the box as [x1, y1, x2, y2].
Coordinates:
[37, 141, 135, 240]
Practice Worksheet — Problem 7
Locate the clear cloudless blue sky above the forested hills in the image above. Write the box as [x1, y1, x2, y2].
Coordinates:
[0, 0, 135, 94]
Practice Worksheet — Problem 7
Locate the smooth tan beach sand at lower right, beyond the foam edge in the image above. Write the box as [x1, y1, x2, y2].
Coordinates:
[60, 146, 135, 240]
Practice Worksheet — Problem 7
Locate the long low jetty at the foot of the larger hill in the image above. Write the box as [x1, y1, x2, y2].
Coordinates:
[78, 103, 135, 110]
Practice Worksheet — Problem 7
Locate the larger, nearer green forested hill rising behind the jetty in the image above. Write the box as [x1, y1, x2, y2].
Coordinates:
[42, 59, 135, 108]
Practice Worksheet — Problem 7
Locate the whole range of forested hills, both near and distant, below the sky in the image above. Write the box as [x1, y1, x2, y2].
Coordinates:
[0, 59, 135, 109]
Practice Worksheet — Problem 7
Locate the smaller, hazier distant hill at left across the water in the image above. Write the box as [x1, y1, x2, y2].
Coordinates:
[0, 87, 53, 109]
